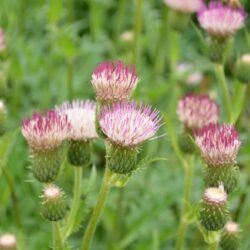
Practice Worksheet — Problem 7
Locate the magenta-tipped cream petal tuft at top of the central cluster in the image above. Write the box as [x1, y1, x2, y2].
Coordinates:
[91, 61, 138, 101]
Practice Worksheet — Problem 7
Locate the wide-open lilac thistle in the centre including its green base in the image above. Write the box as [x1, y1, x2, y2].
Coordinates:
[100, 102, 161, 174]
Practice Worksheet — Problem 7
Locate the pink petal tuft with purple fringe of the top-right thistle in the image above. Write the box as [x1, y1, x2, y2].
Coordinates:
[198, 1, 247, 38]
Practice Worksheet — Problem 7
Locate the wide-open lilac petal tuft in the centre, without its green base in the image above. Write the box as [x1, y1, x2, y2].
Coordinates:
[99, 102, 161, 148]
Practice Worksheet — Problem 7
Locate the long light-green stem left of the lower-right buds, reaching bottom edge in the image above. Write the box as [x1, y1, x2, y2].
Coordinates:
[175, 155, 194, 250]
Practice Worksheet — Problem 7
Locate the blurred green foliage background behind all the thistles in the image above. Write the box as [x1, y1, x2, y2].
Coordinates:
[0, 0, 250, 250]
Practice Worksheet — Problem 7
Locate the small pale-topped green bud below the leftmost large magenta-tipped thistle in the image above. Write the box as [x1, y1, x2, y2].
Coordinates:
[41, 184, 66, 221]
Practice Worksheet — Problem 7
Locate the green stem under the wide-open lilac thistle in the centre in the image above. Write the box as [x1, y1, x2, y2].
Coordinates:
[81, 166, 111, 250]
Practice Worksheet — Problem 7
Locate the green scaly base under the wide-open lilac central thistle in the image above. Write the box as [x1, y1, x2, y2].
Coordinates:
[107, 144, 138, 174]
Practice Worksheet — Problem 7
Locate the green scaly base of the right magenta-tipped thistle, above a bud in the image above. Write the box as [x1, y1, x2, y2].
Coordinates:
[204, 166, 239, 193]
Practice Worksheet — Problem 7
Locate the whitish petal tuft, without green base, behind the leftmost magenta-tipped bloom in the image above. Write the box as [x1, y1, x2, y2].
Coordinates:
[56, 100, 98, 141]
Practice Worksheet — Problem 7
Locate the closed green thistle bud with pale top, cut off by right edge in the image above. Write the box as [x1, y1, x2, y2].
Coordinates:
[235, 54, 250, 83]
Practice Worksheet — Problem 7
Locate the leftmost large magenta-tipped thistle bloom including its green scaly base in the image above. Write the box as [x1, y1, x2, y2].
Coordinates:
[22, 111, 71, 182]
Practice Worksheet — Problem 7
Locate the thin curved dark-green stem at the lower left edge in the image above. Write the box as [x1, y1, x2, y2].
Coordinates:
[1, 166, 22, 228]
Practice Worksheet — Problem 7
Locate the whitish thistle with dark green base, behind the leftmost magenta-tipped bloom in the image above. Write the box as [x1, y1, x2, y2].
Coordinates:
[56, 100, 98, 166]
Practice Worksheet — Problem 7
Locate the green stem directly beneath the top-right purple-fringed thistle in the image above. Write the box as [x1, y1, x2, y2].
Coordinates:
[214, 64, 232, 122]
